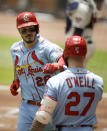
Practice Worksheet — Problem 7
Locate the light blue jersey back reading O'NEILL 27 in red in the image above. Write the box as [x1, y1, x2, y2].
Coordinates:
[45, 68, 103, 131]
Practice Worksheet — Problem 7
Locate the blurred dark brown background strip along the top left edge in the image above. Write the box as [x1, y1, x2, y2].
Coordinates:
[0, 0, 67, 17]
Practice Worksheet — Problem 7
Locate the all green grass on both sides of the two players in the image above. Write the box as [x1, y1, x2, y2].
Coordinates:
[0, 36, 107, 92]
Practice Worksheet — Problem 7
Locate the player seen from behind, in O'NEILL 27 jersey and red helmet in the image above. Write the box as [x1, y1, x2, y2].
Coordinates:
[30, 36, 103, 131]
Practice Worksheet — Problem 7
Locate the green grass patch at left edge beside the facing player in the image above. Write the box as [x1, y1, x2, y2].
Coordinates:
[0, 36, 19, 85]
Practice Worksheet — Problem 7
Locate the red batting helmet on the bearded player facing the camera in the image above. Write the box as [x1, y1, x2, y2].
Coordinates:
[17, 12, 39, 32]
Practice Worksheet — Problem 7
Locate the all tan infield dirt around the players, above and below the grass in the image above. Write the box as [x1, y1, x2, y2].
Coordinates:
[0, 12, 107, 131]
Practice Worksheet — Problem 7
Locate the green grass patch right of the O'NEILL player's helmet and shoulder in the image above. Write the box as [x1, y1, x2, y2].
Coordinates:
[87, 51, 107, 92]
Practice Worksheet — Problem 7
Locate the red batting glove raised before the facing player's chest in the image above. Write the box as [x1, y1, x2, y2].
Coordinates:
[43, 63, 64, 74]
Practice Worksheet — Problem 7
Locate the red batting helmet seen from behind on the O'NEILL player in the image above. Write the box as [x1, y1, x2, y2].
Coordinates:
[64, 36, 87, 59]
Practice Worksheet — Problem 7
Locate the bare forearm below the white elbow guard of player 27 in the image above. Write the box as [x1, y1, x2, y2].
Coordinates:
[30, 119, 45, 131]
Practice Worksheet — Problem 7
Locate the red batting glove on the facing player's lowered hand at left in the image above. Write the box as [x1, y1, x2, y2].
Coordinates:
[10, 79, 20, 96]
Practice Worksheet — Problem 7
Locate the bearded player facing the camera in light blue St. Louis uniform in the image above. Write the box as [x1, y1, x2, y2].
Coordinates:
[10, 12, 63, 131]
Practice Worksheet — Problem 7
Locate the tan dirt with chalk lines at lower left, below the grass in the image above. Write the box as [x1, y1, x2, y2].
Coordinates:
[0, 90, 20, 131]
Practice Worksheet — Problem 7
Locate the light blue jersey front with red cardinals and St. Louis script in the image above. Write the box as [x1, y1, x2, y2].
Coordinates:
[10, 36, 63, 101]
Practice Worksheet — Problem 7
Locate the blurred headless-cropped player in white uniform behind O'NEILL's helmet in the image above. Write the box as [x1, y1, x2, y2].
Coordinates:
[66, 0, 103, 65]
